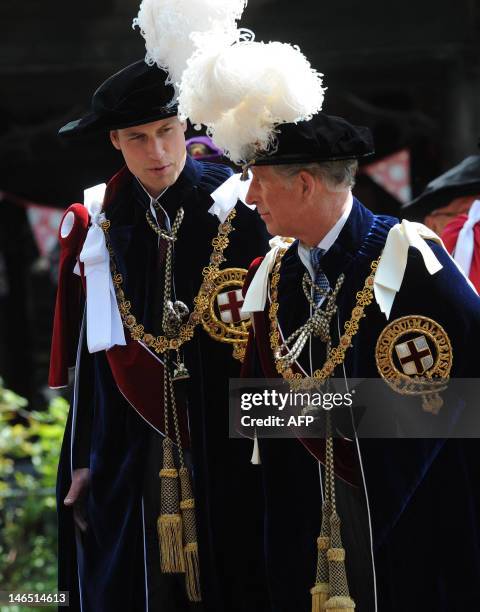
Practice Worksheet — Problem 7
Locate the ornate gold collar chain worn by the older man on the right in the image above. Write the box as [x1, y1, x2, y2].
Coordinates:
[268, 249, 380, 384]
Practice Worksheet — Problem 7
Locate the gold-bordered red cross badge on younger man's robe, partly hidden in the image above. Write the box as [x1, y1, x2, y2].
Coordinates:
[198, 268, 251, 361]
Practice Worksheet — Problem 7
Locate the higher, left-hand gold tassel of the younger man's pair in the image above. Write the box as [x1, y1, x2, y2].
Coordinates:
[157, 437, 185, 574]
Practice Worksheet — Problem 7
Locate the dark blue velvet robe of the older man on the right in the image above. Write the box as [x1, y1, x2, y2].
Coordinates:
[244, 199, 480, 612]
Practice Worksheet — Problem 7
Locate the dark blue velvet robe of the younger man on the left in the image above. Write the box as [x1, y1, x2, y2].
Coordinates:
[57, 158, 267, 612]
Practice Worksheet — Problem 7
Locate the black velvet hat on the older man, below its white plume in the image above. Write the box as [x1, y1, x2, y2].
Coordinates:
[255, 113, 375, 166]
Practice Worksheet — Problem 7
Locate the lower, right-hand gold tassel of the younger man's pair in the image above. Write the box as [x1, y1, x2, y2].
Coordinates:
[180, 467, 202, 601]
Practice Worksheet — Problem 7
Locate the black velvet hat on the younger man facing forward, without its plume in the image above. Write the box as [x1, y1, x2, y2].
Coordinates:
[59, 60, 177, 137]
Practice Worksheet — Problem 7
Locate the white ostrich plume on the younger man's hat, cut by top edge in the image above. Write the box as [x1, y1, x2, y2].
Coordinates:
[133, 0, 247, 93]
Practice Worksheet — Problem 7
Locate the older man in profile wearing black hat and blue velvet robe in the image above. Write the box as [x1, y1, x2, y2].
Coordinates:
[243, 113, 480, 612]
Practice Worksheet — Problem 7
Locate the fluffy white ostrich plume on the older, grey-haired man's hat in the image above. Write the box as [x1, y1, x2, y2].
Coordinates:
[178, 40, 325, 163]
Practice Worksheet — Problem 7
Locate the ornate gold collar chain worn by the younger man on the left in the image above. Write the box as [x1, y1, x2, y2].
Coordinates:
[101, 209, 236, 353]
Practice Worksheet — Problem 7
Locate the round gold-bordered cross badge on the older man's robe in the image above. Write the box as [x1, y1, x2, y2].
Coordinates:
[375, 315, 453, 414]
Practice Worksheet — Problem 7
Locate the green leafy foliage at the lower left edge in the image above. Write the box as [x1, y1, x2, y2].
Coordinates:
[0, 380, 68, 612]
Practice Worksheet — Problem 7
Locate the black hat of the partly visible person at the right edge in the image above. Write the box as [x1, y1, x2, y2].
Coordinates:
[403, 155, 480, 215]
